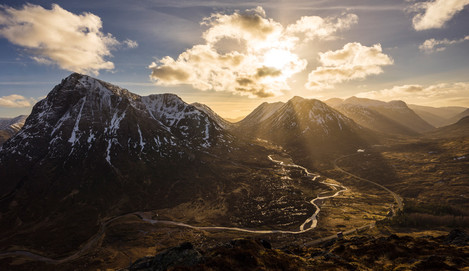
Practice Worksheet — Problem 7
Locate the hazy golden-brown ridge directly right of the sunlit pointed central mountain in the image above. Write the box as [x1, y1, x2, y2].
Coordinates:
[334, 97, 434, 135]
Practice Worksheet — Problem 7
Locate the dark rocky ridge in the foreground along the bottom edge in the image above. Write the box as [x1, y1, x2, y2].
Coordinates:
[123, 229, 469, 271]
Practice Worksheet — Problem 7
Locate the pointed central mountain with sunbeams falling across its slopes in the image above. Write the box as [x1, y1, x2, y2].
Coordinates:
[236, 97, 372, 165]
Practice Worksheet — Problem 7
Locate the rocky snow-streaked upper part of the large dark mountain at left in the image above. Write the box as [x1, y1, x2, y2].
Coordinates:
[0, 74, 229, 173]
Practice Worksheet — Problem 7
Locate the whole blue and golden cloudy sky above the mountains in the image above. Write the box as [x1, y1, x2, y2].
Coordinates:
[0, 0, 469, 118]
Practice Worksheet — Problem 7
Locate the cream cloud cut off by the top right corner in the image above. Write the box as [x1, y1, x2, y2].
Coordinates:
[409, 0, 469, 31]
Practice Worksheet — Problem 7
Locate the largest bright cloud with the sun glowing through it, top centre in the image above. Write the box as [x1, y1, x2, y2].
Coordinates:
[149, 7, 358, 97]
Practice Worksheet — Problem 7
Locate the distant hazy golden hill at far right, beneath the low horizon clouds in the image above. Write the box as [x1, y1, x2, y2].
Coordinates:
[409, 104, 467, 127]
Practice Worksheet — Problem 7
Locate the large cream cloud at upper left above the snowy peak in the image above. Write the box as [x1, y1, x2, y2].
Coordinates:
[0, 4, 137, 75]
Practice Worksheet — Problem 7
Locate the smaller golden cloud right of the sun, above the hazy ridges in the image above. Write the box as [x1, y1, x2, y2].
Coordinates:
[305, 42, 393, 90]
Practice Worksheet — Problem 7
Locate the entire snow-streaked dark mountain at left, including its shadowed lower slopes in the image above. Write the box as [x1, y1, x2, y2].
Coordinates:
[0, 74, 256, 253]
